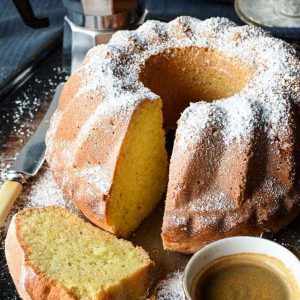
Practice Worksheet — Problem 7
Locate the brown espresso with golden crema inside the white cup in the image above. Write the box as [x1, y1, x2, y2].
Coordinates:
[191, 253, 300, 300]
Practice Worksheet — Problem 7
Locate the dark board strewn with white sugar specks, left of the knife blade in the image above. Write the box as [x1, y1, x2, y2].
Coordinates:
[0, 64, 68, 177]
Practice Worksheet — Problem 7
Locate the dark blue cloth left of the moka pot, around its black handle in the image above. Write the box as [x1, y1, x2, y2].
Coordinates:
[0, 0, 65, 87]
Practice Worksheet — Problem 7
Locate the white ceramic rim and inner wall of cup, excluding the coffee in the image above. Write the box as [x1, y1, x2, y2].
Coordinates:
[183, 236, 300, 300]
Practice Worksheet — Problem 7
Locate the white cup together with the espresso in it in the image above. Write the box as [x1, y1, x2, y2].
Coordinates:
[183, 236, 300, 300]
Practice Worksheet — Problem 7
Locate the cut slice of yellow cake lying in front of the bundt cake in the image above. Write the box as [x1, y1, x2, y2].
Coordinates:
[5, 206, 153, 300]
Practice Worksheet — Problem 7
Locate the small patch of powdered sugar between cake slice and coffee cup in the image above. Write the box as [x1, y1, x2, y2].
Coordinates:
[154, 271, 184, 300]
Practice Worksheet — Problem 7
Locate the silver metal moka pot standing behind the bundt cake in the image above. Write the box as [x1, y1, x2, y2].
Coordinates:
[62, 0, 140, 73]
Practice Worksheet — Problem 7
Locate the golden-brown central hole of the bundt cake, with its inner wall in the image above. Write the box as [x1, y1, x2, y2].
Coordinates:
[140, 47, 254, 129]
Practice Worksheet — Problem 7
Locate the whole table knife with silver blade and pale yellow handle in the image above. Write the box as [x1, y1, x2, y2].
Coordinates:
[0, 83, 64, 227]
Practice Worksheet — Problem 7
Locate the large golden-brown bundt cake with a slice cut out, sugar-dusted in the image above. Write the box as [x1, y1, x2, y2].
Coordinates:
[47, 17, 300, 253]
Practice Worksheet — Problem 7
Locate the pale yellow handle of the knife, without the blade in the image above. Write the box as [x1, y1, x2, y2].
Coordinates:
[0, 180, 23, 227]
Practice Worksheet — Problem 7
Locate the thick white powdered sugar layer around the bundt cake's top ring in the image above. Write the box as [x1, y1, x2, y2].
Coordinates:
[82, 17, 300, 147]
